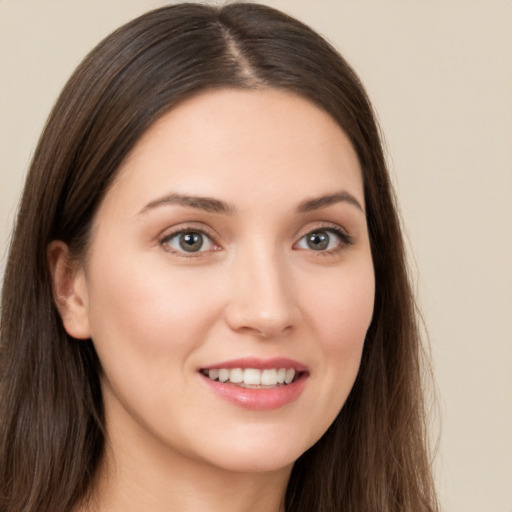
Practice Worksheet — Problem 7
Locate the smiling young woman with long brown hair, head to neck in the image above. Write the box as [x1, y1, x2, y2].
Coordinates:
[0, 4, 437, 512]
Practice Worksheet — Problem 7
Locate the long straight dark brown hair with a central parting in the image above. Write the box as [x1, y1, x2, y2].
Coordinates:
[0, 3, 437, 512]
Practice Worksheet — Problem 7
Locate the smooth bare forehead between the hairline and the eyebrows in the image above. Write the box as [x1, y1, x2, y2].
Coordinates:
[103, 89, 364, 214]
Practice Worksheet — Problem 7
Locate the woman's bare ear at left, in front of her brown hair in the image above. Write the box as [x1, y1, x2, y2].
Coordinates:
[47, 240, 91, 339]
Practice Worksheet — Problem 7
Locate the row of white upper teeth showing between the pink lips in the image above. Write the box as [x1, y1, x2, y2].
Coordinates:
[203, 368, 296, 388]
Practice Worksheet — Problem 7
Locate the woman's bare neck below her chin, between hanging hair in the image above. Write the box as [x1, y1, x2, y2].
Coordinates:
[88, 446, 291, 512]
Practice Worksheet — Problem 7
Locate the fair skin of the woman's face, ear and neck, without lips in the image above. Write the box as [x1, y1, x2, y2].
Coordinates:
[49, 89, 375, 512]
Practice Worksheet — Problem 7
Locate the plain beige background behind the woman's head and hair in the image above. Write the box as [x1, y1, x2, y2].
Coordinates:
[0, 0, 512, 512]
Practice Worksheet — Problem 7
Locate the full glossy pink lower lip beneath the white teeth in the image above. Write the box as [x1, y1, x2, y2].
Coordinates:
[201, 373, 307, 411]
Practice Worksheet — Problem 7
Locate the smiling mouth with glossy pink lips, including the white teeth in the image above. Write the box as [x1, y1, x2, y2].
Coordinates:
[200, 358, 309, 410]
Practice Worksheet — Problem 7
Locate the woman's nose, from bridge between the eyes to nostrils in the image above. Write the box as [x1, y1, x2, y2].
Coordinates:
[225, 245, 300, 338]
